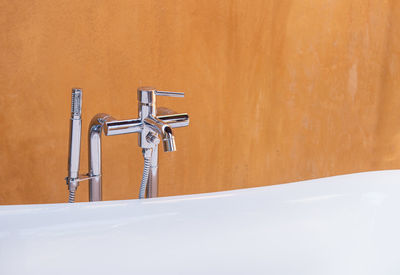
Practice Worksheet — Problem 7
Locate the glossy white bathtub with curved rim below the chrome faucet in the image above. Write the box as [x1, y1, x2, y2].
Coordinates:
[0, 170, 400, 275]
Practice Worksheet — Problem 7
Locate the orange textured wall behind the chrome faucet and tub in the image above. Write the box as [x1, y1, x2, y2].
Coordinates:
[0, 0, 400, 204]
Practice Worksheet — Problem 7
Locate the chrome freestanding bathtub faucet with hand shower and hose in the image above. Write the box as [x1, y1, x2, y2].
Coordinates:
[66, 87, 189, 202]
